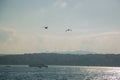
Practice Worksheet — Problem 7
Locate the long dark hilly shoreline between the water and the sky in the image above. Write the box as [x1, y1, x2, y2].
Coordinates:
[0, 53, 120, 67]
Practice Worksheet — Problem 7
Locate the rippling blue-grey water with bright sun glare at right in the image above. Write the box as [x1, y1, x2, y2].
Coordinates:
[0, 66, 120, 80]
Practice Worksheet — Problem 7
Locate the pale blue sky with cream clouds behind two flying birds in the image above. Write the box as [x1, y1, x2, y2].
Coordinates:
[0, 0, 120, 54]
